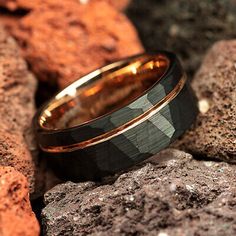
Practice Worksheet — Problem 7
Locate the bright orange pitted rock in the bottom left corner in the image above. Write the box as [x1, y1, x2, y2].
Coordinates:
[0, 166, 39, 236]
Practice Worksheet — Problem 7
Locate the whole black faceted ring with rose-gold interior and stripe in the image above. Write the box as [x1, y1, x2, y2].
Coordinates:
[34, 51, 198, 180]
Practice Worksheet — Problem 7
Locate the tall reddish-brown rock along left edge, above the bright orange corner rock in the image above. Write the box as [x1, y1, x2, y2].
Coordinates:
[0, 27, 36, 190]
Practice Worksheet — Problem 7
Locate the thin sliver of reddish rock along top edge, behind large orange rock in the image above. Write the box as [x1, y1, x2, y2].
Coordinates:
[0, 0, 131, 11]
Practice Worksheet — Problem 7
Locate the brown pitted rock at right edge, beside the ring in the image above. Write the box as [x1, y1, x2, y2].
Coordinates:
[174, 40, 236, 163]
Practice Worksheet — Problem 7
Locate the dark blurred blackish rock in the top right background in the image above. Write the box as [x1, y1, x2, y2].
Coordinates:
[127, 0, 236, 75]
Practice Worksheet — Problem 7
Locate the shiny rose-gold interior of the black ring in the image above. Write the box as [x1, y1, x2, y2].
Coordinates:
[39, 54, 170, 130]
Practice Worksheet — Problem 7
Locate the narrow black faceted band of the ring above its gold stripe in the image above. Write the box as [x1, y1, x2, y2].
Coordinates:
[34, 52, 183, 147]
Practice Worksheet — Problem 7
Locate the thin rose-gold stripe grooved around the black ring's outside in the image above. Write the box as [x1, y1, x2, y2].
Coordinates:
[40, 74, 187, 153]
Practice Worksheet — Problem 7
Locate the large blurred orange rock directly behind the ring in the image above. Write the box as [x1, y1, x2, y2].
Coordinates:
[11, 1, 143, 88]
